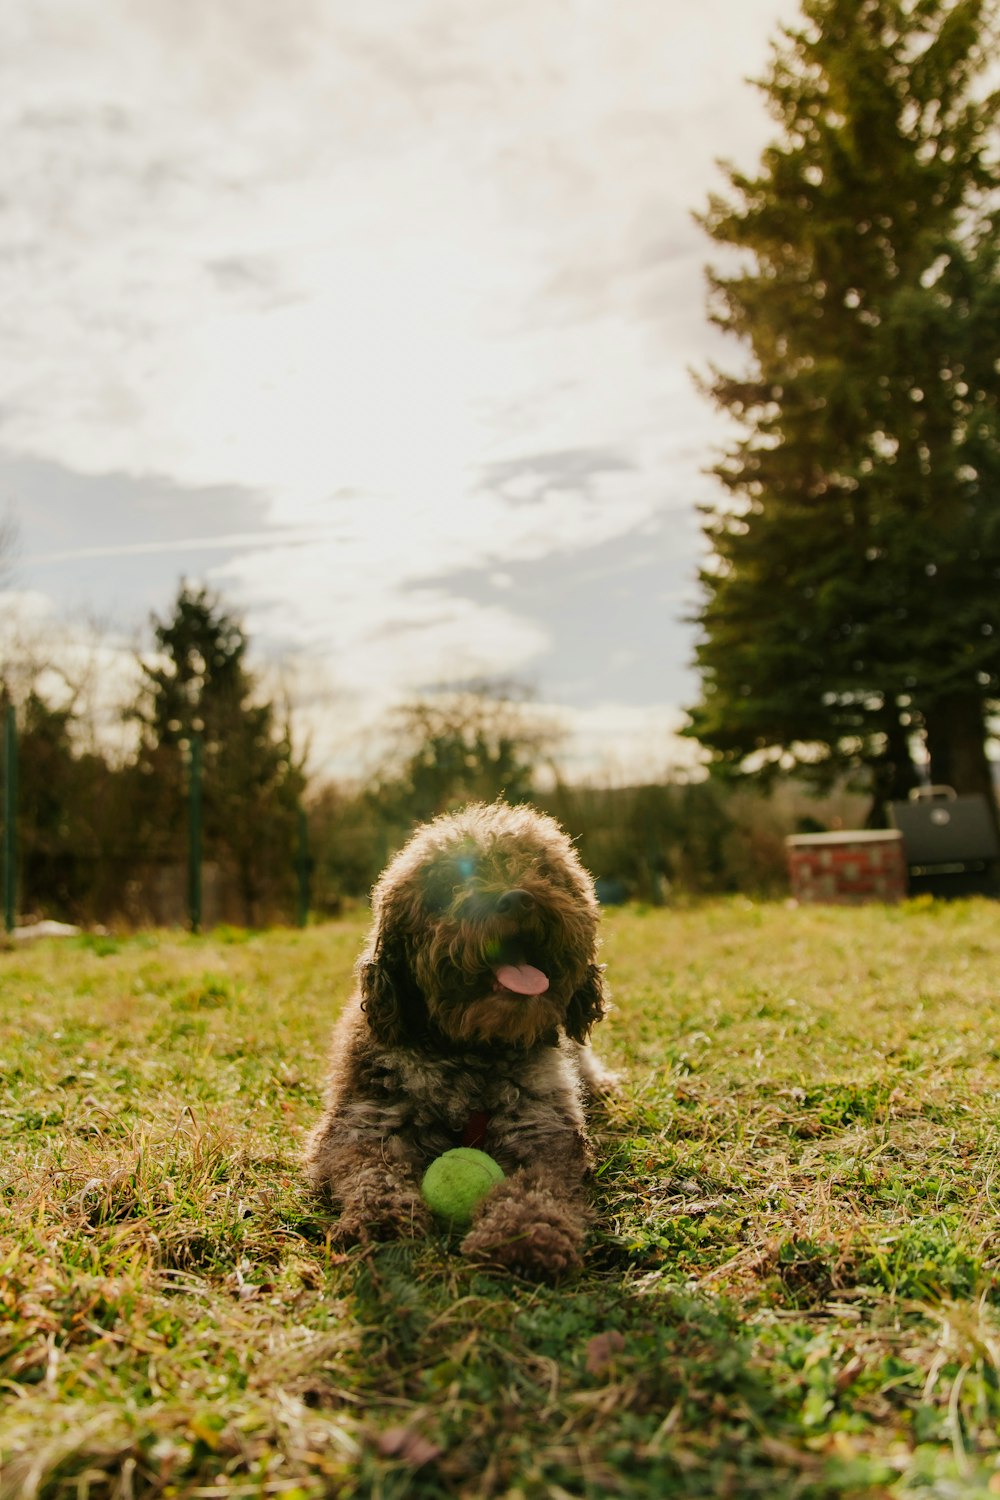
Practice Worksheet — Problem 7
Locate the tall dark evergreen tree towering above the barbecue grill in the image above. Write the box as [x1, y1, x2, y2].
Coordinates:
[693, 0, 1000, 822]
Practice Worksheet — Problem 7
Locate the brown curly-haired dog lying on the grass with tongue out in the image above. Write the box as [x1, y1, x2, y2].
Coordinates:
[306, 803, 612, 1277]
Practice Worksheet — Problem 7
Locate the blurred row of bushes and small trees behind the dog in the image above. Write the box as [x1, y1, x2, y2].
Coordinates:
[0, 585, 867, 926]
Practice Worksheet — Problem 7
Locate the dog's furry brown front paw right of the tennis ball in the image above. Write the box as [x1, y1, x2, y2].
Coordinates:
[462, 1188, 583, 1280]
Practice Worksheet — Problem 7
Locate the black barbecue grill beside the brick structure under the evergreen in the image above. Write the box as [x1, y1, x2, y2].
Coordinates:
[889, 786, 1000, 896]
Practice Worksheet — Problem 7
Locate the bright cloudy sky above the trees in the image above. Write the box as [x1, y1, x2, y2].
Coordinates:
[0, 0, 796, 780]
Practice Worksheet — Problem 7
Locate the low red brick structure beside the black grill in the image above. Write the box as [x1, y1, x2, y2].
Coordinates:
[786, 828, 907, 906]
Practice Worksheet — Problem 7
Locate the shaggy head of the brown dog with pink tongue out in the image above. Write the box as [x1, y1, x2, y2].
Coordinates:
[360, 803, 604, 1046]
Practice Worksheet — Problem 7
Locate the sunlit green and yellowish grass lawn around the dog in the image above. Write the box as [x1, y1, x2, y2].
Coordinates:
[0, 902, 1000, 1500]
